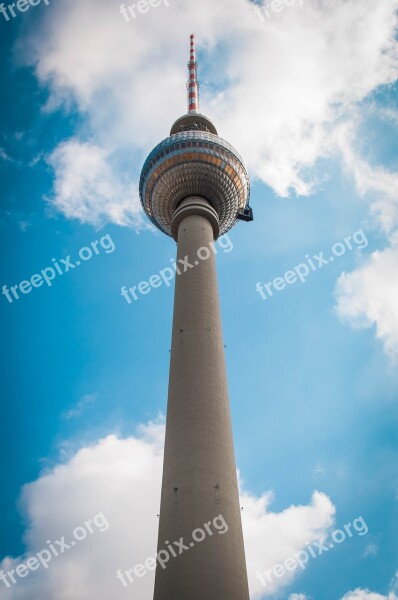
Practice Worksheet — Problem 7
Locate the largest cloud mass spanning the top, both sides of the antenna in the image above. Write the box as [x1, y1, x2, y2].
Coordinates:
[17, 0, 398, 216]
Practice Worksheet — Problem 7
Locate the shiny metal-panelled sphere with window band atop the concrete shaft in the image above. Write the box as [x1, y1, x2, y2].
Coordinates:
[140, 124, 250, 236]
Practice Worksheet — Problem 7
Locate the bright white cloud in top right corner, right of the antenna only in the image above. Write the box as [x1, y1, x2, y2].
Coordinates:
[218, 0, 398, 196]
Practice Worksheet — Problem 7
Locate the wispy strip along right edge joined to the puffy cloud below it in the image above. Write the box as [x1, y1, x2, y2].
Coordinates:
[334, 110, 398, 357]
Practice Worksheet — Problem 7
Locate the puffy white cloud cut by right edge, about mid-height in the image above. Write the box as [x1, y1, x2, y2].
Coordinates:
[336, 246, 398, 358]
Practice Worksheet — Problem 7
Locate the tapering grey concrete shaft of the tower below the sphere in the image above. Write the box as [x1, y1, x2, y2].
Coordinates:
[154, 198, 249, 600]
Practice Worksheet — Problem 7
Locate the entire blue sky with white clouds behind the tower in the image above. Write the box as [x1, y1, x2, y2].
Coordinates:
[0, 0, 398, 600]
